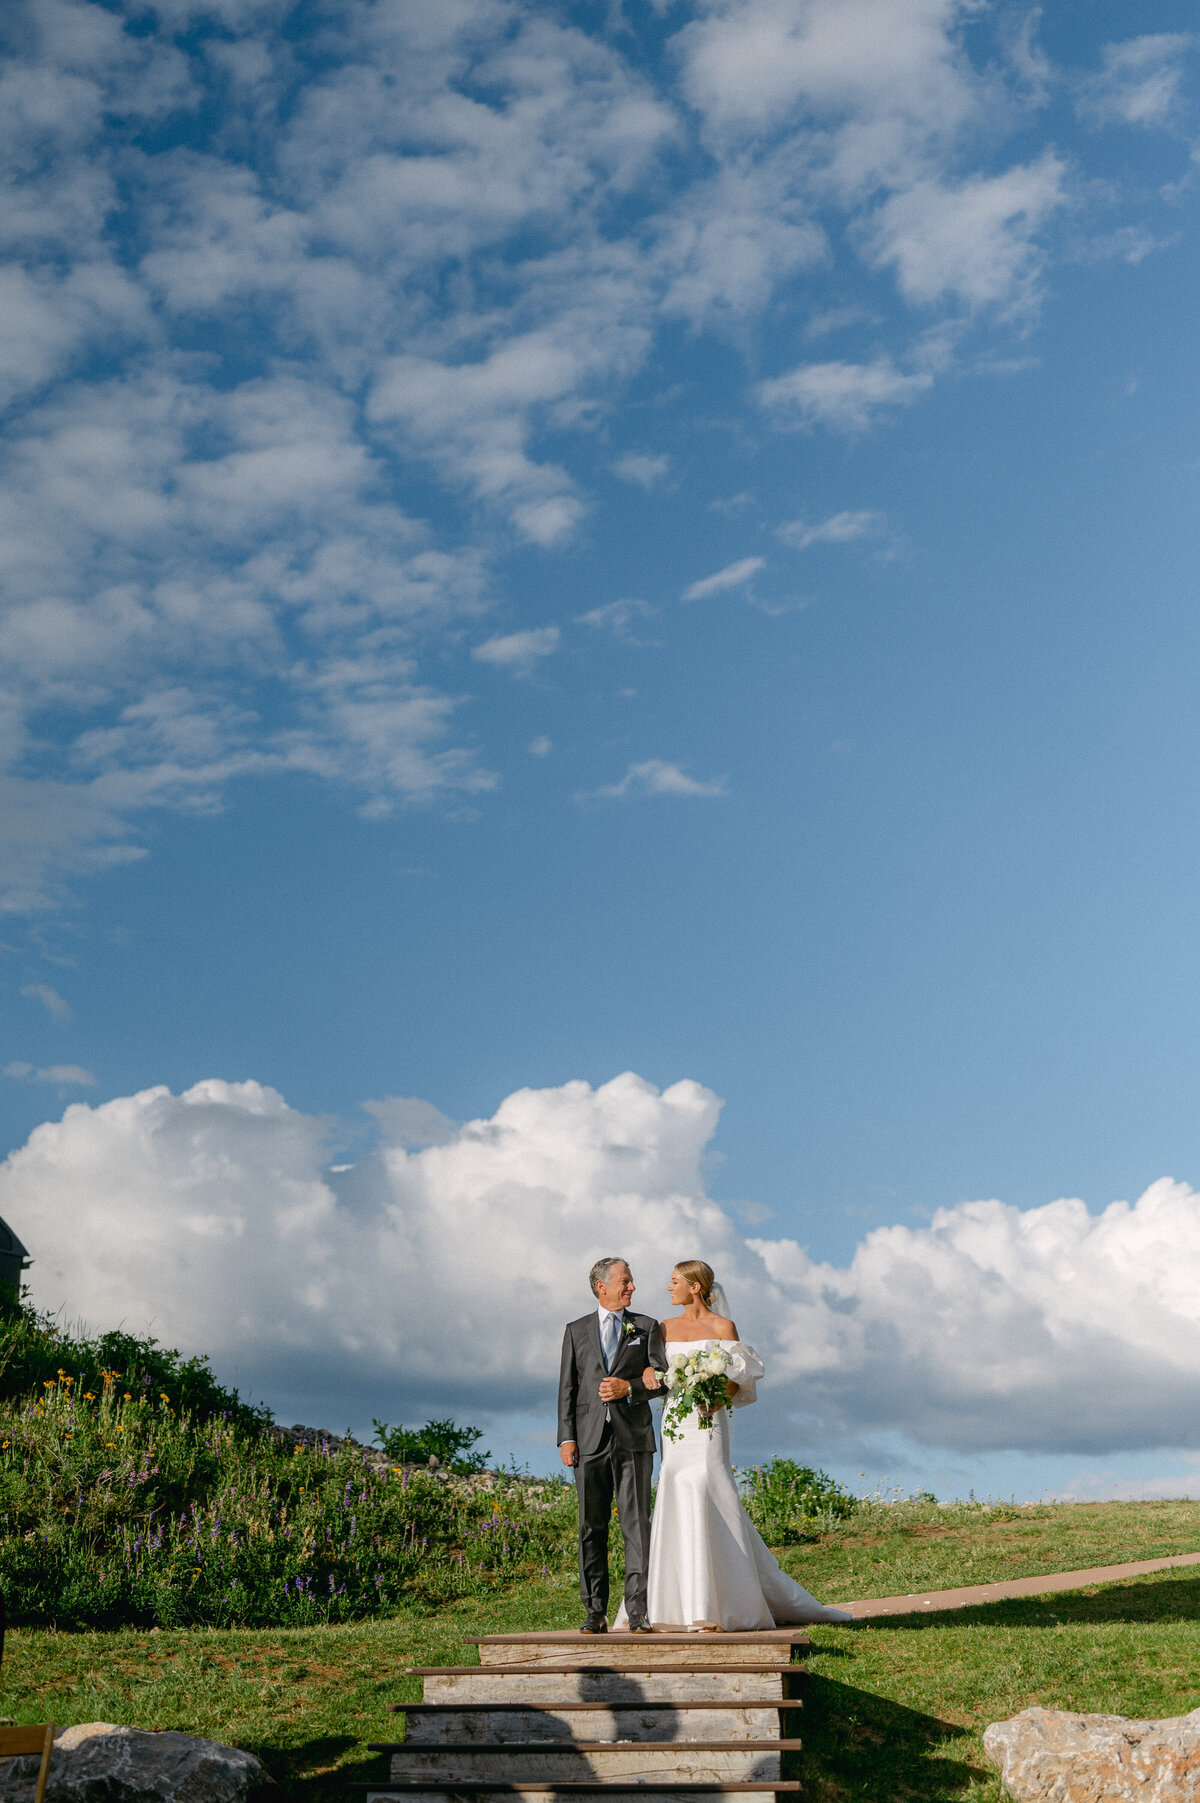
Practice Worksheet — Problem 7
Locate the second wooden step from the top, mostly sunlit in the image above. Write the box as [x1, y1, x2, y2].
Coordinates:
[409, 1661, 802, 1709]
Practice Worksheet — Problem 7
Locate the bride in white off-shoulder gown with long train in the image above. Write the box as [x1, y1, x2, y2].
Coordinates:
[618, 1258, 854, 1632]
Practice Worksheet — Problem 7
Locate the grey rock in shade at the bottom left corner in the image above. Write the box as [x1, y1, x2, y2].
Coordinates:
[0, 1722, 272, 1803]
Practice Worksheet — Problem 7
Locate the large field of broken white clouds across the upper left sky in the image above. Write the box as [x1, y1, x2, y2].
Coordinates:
[0, 0, 1191, 911]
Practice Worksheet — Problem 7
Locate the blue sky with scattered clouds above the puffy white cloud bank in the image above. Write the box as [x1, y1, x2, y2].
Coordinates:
[0, 0, 1200, 1487]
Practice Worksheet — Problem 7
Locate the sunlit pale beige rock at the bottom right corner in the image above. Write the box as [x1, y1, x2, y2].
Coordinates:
[984, 1709, 1200, 1803]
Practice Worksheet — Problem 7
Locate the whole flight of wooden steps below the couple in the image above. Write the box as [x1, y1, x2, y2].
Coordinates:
[368, 1628, 809, 1803]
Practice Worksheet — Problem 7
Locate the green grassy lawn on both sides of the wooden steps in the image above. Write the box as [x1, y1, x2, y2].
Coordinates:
[0, 1504, 1200, 1803]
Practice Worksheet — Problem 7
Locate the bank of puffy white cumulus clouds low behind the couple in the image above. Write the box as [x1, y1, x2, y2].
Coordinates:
[0, 1073, 1200, 1457]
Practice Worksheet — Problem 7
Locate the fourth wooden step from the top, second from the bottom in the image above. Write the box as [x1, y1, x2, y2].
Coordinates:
[375, 1740, 800, 1785]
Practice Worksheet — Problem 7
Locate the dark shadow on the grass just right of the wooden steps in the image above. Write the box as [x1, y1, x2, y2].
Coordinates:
[784, 1673, 995, 1803]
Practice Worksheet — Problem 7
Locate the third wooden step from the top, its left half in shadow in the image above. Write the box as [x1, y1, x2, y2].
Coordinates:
[404, 1702, 800, 1745]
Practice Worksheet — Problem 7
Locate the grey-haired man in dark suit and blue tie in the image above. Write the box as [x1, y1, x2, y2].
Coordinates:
[559, 1258, 667, 1634]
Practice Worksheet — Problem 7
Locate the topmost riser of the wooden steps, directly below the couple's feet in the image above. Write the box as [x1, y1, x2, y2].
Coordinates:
[467, 1628, 811, 1668]
